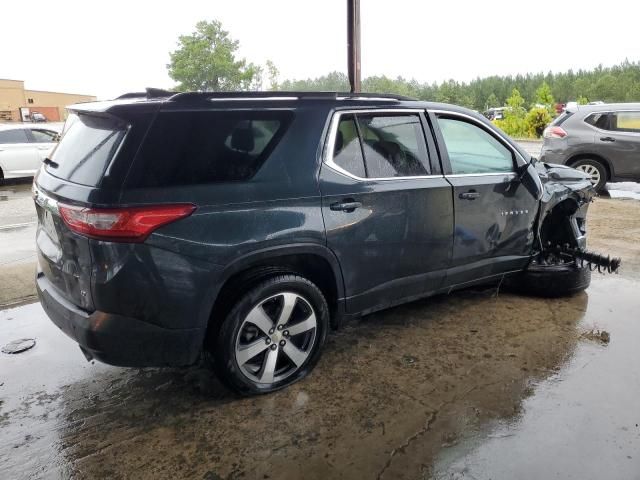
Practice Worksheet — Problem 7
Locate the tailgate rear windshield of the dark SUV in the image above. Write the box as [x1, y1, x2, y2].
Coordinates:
[46, 114, 126, 187]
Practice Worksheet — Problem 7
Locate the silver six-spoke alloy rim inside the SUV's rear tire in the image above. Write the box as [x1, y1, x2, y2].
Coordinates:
[235, 292, 318, 385]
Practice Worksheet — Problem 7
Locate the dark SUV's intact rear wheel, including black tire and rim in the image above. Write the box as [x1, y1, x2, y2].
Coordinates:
[208, 275, 329, 395]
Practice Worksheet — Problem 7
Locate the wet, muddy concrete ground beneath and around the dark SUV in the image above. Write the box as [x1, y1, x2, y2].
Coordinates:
[0, 178, 640, 480]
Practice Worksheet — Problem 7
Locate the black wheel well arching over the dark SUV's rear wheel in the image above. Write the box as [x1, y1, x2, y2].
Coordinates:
[208, 254, 338, 333]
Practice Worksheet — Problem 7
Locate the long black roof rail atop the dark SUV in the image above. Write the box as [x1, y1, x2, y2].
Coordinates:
[169, 90, 415, 102]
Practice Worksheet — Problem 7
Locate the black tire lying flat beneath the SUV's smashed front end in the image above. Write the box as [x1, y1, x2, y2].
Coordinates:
[506, 264, 591, 298]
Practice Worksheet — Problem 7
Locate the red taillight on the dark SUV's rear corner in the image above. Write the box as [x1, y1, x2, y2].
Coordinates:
[58, 203, 196, 242]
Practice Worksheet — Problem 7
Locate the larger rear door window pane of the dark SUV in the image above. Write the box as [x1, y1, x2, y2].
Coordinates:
[357, 114, 431, 178]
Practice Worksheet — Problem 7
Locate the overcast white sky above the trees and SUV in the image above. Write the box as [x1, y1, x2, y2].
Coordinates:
[0, 0, 640, 99]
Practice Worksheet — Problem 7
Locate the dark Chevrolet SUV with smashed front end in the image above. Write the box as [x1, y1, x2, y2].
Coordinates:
[34, 90, 594, 393]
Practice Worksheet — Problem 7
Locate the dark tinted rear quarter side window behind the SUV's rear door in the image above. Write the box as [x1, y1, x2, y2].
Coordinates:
[128, 110, 293, 187]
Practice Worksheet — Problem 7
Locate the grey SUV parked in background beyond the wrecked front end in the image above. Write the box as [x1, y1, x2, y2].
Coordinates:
[541, 103, 640, 190]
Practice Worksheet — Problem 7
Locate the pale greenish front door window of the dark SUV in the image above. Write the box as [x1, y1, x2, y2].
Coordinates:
[438, 118, 514, 174]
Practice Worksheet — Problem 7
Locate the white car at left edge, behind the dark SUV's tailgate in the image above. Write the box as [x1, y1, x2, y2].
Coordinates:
[0, 124, 58, 180]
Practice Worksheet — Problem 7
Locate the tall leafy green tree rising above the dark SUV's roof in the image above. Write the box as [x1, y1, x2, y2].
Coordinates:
[167, 20, 262, 92]
